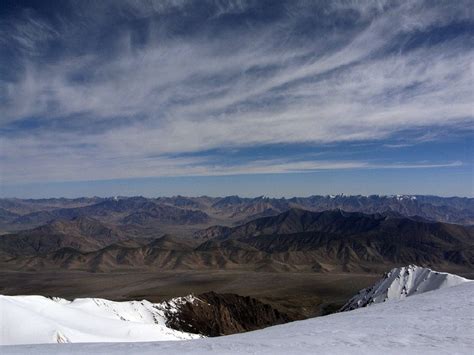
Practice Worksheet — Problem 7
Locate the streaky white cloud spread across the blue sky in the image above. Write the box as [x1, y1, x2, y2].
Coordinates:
[0, 1, 474, 182]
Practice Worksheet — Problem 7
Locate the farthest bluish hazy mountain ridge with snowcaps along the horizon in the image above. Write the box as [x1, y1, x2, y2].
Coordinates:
[0, 195, 474, 234]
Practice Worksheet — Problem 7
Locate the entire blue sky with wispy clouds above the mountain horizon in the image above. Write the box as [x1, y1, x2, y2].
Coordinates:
[0, 0, 474, 198]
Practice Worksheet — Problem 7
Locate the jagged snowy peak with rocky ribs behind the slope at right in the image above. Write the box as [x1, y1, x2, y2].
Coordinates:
[341, 265, 469, 311]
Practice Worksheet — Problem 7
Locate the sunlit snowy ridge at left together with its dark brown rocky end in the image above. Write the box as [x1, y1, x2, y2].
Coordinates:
[0, 292, 293, 345]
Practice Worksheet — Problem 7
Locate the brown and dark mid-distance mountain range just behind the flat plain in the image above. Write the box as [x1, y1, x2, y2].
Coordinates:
[6, 209, 474, 272]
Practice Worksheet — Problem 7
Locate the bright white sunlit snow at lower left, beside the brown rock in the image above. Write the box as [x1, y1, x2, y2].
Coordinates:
[0, 296, 199, 353]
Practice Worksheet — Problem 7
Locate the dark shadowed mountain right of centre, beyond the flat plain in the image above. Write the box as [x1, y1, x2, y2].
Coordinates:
[193, 209, 474, 270]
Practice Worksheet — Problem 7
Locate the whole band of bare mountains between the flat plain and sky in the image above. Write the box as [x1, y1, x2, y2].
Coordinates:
[0, 196, 474, 272]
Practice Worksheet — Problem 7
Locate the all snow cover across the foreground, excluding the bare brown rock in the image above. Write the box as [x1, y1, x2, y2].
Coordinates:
[0, 265, 474, 355]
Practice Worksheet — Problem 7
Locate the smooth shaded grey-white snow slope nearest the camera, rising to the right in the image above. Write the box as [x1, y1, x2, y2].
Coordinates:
[0, 282, 474, 355]
